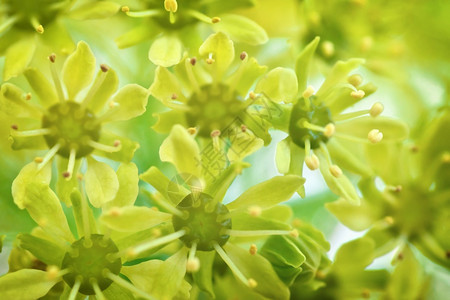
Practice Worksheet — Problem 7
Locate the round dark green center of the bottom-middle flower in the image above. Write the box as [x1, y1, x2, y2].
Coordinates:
[172, 193, 231, 251]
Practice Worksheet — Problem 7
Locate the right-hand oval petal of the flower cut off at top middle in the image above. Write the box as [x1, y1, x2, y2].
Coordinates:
[212, 14, 269, 45]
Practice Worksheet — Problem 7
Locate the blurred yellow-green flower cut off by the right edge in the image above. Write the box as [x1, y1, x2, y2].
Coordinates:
[327, 112, 450, 269]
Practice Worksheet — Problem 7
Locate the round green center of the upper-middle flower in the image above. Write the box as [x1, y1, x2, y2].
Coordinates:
[186, 84, 245, 137]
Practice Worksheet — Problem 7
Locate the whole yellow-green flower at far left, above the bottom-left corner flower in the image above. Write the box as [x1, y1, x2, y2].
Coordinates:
[0, 42, 148, 207]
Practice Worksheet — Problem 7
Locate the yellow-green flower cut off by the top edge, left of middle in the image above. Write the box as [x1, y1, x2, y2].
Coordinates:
[116, 0, 268, 67]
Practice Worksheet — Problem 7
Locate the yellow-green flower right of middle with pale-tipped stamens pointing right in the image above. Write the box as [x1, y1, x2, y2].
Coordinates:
[255, 38, 408, 204]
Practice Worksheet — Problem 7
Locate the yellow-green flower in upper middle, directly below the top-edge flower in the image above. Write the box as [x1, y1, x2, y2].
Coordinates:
[150, 32, 270, 154]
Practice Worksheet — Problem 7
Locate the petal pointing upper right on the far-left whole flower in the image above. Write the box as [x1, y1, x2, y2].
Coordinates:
[102, 84, 149, 122]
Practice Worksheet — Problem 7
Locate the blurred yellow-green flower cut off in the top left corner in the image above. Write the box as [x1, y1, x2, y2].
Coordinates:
[0, 0, 119, 80]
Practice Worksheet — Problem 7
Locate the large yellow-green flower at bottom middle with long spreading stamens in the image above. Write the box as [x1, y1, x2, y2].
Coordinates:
[101, 125, 304, 299]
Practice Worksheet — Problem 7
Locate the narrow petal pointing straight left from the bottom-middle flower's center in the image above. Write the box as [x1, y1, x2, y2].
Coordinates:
[100, 206, 172, 232]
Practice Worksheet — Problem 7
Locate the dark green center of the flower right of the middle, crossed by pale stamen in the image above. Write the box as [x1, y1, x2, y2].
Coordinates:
[289, 97, 332, 149]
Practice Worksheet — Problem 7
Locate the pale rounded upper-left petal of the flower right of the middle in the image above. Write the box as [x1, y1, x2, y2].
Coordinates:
[255, 67, 298, 103]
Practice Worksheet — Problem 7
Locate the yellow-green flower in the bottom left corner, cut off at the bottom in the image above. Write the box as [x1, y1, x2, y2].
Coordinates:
[0, 164, 163, 300]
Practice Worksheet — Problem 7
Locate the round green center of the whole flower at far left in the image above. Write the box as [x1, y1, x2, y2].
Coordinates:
[42, 101, 101, 158]
